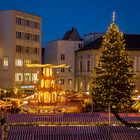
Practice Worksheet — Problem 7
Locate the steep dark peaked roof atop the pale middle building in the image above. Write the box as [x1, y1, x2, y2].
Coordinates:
[63, 28, 82, 41]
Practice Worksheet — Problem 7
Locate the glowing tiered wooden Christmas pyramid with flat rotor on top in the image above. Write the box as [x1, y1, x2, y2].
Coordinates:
[27, 64, 68, 103]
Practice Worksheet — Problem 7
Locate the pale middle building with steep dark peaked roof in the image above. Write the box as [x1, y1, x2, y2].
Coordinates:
[45, 28, 83, 91]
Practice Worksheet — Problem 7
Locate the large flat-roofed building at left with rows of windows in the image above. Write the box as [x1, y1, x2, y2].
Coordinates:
[0, 10, 42, 92]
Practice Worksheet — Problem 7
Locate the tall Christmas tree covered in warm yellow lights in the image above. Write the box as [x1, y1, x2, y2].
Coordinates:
[91, 15, 139, 126]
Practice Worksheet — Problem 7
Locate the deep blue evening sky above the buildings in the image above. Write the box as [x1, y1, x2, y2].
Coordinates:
[0, 0, 140, 47]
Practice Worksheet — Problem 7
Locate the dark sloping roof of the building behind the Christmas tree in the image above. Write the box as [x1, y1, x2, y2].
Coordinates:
[77, 34, 140, 52]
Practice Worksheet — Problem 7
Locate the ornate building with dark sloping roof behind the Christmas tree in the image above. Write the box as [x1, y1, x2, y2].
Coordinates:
[75, 34, 140, 92]
